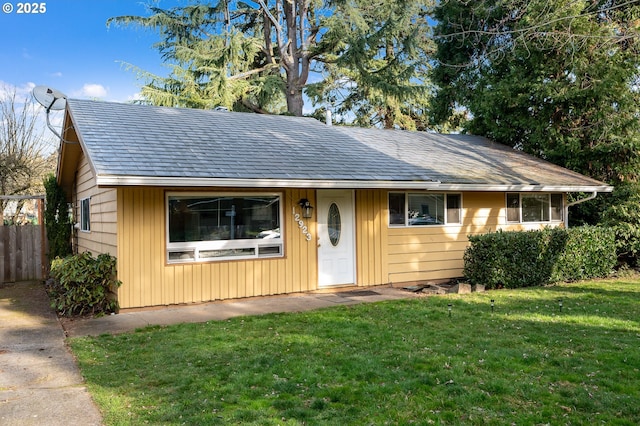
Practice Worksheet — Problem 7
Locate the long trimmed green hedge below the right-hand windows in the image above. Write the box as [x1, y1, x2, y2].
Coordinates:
[464, 226, 617, 288]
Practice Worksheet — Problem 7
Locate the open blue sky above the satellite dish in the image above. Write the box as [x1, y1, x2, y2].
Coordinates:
[0, 0, 188, 102]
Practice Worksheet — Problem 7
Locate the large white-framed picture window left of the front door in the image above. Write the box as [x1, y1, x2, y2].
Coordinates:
[166, 193, 284, 263]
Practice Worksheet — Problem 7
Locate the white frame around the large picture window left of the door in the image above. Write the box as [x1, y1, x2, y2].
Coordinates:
[165, 191, 284, 264]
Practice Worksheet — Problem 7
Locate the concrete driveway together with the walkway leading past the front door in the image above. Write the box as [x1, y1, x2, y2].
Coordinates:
[0, 282, 416, 426]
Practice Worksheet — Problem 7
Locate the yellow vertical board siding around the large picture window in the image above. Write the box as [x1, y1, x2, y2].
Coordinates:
[117, 187, 317, 308]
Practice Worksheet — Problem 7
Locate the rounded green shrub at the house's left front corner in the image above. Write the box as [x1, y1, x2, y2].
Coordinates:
[48, 252, 121, 316]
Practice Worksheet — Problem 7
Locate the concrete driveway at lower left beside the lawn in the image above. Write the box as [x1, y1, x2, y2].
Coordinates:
[0, 282, 102, 426]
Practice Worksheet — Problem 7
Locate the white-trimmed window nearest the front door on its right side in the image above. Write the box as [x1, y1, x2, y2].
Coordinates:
[389, 192, 462, 226]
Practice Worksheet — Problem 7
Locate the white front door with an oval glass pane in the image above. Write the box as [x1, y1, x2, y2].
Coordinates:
[316, 190, 355, 287]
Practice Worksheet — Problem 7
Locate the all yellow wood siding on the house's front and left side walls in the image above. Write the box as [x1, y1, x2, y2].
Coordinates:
[74, 181, 560, 308]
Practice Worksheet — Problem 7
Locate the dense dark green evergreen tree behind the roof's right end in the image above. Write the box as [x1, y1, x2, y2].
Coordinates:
[433, 0, 640, 185]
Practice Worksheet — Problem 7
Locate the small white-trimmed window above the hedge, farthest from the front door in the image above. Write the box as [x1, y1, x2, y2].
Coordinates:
[507, 192, 564, 223]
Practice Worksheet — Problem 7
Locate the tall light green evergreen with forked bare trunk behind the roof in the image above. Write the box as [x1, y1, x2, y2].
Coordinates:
[108, 0, 433, 129]
